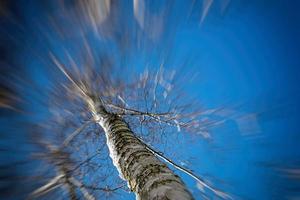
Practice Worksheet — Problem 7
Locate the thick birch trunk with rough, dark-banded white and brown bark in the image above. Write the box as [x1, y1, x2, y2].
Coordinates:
[89, 100, 193, 200]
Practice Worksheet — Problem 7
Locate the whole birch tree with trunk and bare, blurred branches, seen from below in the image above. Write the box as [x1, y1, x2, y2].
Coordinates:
[0, 0, 234, 200]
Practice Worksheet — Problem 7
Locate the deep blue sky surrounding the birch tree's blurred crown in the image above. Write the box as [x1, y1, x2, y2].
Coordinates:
[0, 0, 300, 199]
